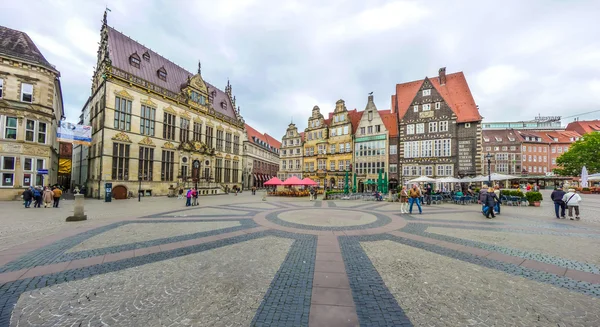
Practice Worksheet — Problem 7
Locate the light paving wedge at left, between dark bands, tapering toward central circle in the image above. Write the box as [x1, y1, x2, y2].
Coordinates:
[66, 221, 240, 253]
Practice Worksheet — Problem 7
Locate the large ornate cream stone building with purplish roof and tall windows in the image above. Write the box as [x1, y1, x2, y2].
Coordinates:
[87, 12, 245, 198]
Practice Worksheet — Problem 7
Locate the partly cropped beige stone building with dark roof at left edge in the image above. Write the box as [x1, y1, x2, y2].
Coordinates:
[0, 26, 64, 200]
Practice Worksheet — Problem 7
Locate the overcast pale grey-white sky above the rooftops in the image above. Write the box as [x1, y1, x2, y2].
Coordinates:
[0, 0, 600, 139]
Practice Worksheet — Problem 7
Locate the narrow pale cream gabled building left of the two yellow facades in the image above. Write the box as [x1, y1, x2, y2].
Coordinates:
[277, 123, 304, 181]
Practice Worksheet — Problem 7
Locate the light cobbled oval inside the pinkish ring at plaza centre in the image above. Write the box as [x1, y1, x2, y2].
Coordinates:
[277, 209, 377, 227]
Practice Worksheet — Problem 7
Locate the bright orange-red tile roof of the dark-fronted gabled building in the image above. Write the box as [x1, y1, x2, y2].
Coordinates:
[392, 72, 482, 123]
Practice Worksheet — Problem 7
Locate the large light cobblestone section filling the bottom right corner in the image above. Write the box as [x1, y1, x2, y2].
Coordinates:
[362, 241, 600, 326]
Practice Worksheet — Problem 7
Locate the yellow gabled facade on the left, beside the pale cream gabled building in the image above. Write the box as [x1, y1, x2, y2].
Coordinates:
[302, 106, 329, 187]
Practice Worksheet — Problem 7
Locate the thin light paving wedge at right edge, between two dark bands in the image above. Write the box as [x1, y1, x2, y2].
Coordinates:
[427, 227, 600, 265]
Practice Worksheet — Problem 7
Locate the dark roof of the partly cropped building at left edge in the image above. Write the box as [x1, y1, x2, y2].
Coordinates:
[0, 26, 56, 71]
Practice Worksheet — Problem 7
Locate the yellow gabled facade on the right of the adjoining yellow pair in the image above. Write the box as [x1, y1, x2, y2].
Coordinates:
[326, 100, 353, 189]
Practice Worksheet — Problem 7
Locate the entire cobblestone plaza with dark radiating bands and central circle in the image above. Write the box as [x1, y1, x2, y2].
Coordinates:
[0, 192, 600, 326]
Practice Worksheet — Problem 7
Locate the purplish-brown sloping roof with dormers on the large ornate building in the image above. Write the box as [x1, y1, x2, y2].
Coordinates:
[107, 26, 237, 118]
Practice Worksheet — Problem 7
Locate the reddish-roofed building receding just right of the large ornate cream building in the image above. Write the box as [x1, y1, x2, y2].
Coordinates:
[244, 124, 281, 189]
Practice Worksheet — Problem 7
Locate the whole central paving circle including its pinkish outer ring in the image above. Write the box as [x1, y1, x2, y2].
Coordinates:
[266, 208, 391, 231]
